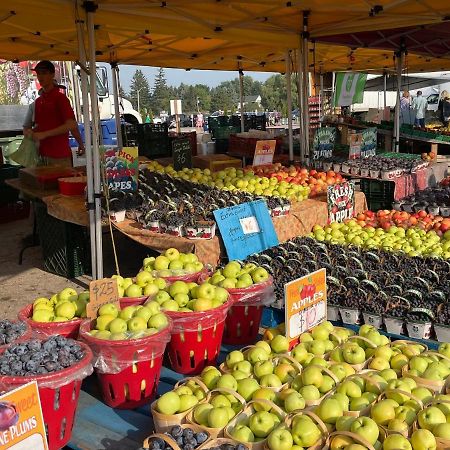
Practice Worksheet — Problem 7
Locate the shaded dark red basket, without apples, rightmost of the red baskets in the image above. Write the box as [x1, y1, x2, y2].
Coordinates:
[223, 277, 273, 345]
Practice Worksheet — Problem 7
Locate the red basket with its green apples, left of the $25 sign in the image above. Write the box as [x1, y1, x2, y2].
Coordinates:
[18, 288, 89, 339]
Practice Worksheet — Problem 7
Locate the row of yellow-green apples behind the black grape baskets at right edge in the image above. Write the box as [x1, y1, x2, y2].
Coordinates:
[310, 219, 450, 259]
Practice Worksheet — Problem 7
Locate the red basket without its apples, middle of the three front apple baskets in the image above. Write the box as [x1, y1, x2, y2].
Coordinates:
[166, 299, 232, 375]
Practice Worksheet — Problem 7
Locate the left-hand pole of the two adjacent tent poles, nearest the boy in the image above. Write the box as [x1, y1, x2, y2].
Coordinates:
[74, 20, 97, 279]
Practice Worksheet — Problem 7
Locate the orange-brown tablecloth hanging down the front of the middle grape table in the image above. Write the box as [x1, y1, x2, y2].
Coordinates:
[112, 192, 367, 266]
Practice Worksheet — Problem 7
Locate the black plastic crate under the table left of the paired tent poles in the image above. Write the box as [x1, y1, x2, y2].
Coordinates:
[33, 202, 91, 278]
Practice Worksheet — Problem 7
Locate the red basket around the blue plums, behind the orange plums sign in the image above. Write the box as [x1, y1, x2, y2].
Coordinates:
[0, 342, 92, 450]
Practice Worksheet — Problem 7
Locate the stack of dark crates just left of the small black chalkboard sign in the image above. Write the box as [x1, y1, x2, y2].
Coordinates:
[137, 123, 171, 159]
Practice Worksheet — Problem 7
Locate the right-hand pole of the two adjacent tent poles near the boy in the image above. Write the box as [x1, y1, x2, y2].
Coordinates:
[87, 5, 103, 279]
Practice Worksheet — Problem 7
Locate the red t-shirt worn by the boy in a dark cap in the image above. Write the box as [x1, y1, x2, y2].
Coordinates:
[34, 88, 75, 158]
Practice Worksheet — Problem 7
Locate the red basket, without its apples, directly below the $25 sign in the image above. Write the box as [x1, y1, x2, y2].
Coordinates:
[80, 318, 172, 409]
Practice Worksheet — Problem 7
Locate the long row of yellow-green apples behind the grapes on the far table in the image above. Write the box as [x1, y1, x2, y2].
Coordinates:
[147, 161, 310, 201]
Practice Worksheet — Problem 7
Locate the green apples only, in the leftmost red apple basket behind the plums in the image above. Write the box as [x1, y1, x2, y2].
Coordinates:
[31, 288, 89, 322]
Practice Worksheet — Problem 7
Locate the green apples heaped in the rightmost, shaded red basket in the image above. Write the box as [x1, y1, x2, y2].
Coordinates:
[206, 261, 269, 289]
